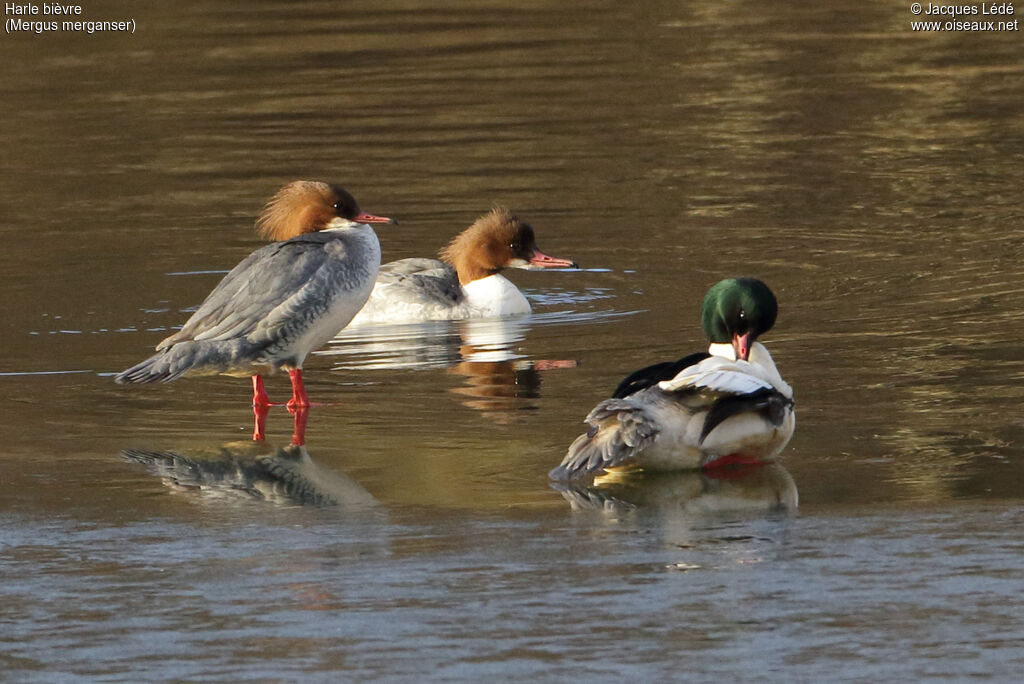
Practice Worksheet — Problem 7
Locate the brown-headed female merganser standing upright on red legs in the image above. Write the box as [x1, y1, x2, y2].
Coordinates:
[115, 180, 394, 409]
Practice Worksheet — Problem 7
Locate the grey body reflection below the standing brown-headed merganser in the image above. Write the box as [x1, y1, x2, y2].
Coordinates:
[121, 440, 376, 507]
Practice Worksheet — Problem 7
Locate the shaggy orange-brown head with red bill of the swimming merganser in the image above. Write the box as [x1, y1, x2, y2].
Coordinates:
[440, 207, 575, 285]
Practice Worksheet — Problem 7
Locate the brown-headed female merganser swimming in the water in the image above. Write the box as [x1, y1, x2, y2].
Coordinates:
[351, 207, 578, 327]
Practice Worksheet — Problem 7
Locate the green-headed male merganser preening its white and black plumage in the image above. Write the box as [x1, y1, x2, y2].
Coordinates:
[549, 277, 796, 480]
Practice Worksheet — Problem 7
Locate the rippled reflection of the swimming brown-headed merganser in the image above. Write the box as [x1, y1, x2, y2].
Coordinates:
[319, 316, 577, 422]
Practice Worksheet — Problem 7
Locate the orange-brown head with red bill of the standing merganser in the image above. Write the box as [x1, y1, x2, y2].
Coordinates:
[256, 180, 394, 241]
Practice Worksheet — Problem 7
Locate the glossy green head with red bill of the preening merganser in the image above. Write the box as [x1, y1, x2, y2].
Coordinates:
[700, 277, 778, 360]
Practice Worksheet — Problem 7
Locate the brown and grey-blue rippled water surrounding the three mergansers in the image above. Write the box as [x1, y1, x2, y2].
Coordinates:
[0, 0, 1024, 682]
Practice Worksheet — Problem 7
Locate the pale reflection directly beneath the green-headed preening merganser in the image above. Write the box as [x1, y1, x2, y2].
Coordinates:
[551, 463, 799, 514]
